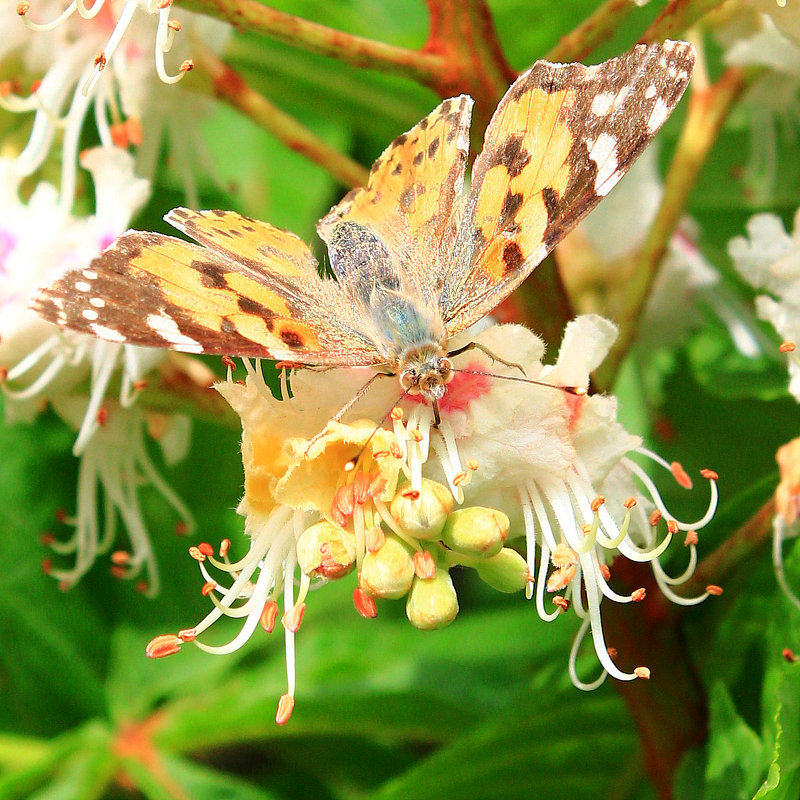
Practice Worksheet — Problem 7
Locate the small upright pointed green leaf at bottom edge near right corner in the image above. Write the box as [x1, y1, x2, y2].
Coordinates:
[703, 682, 764, 800]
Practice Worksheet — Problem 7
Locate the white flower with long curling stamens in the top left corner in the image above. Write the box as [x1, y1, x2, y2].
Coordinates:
[0, 0, 230, 209]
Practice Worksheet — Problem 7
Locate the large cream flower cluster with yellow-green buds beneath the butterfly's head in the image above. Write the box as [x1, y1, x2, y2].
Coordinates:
[148, 315, 720, 723]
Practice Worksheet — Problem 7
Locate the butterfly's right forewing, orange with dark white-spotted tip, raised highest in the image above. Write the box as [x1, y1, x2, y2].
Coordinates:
[441, 41, 695, 336]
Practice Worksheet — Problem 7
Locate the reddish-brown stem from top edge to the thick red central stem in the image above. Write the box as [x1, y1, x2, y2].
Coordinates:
[181, 0, 446, 84]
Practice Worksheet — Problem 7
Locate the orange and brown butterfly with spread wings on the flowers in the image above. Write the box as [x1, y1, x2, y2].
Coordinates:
[34, 41, 695, 418]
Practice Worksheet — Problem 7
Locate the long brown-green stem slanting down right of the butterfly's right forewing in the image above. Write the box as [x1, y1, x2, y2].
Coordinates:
[595, 67, 753, 390]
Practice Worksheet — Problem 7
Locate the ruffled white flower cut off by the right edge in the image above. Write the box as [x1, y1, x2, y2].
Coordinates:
[728, 211, 800, 400]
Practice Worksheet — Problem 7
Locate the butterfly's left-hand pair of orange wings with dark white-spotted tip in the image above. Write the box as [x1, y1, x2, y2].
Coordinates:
[33, 209, 381, 364]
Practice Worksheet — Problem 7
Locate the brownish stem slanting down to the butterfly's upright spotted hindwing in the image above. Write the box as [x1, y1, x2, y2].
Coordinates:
[195, 43, 369, 187]
